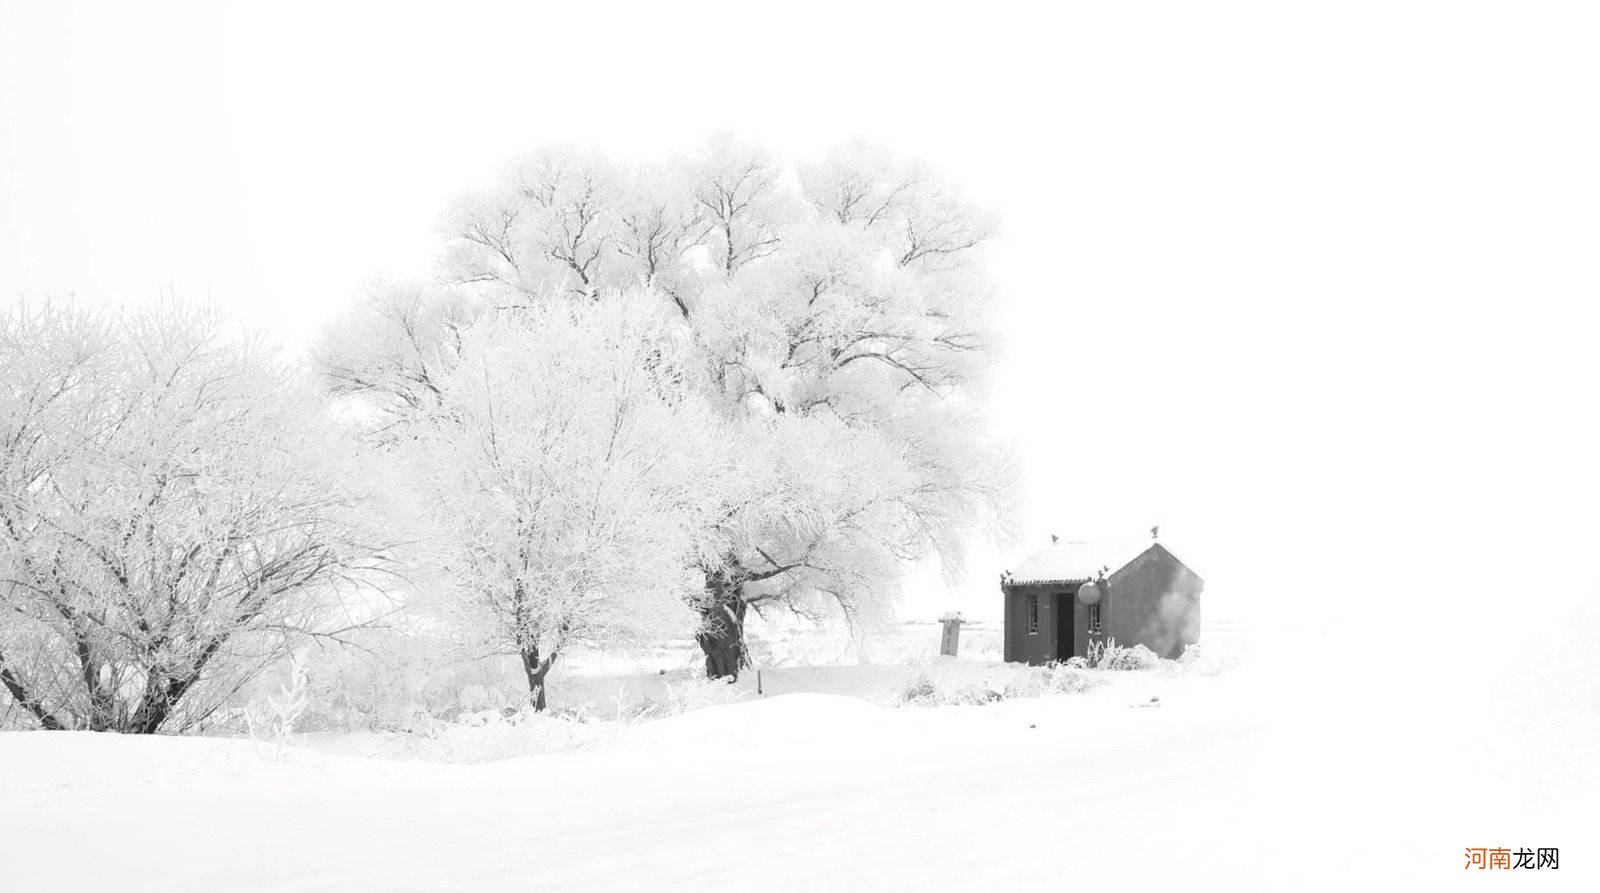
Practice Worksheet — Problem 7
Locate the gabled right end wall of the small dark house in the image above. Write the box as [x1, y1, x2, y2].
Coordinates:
[1101, 544, 1205, 659]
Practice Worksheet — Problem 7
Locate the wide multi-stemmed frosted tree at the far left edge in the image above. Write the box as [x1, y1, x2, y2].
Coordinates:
[0, 304, 385, 733]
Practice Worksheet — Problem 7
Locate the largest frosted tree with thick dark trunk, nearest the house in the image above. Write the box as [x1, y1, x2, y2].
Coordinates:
[323, 138, 1010, 677]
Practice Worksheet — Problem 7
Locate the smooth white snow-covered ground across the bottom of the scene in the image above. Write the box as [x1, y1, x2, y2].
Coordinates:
[0, 636, 1600, 891]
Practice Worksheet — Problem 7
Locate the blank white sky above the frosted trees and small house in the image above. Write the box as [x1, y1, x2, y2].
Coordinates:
[0, 0, 1600, 635]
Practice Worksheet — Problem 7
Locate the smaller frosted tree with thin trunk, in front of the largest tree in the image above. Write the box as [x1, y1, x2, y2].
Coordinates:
[403, 293, 731, 709]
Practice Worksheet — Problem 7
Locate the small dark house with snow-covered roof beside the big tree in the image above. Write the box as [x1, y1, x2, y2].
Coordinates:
[1000, 536, 1205, 664]
